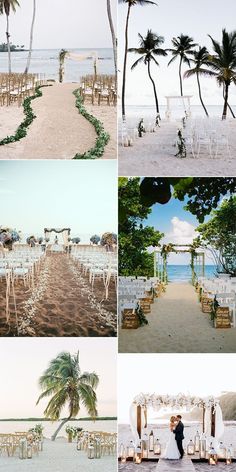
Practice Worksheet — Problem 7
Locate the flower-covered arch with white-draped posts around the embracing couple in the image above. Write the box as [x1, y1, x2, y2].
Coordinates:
[133, 394, 218, 439]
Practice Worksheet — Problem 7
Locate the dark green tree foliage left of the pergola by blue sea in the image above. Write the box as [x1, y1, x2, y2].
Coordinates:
[119, 177, 163, 276]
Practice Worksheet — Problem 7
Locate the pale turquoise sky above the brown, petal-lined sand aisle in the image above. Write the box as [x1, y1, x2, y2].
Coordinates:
[0, 161, 117, 242]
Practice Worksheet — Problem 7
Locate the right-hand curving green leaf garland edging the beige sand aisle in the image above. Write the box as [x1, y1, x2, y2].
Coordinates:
[73, 89, 110, 159]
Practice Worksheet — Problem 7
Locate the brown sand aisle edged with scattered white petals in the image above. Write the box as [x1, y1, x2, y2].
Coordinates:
[0, 253, 117, 337]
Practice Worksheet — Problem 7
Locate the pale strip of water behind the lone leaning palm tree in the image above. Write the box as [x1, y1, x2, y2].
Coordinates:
[0, 420, 117, 438]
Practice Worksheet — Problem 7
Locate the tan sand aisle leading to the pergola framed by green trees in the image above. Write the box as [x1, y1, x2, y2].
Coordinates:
[119, 283, 236, 352]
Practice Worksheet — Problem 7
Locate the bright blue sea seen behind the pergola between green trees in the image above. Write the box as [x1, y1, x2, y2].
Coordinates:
[160, 264, 216, 282]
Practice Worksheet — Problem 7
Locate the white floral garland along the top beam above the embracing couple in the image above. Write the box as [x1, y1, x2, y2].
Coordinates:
[133, 393, 219, 409]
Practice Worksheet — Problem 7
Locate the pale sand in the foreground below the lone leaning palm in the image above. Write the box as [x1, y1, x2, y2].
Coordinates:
[0, 438, 117, 472]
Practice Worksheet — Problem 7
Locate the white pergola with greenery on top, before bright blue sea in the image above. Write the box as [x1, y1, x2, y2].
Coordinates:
[154, 243, 205, 285]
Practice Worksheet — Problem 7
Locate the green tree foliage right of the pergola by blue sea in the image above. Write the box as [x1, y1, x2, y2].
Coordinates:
[197, 196, 236, 277]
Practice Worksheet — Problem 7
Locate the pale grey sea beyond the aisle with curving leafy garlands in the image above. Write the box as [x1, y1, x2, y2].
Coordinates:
[0, 48, 114, 82]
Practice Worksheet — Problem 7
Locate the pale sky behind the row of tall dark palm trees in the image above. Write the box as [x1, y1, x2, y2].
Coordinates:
[118, 0, 236, 105]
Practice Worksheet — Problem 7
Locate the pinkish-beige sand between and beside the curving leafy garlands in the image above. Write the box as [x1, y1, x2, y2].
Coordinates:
[0, 83, 116, 159]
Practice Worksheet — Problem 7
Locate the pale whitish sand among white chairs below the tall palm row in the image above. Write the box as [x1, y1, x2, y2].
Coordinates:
[118, 121, 236, 177]
